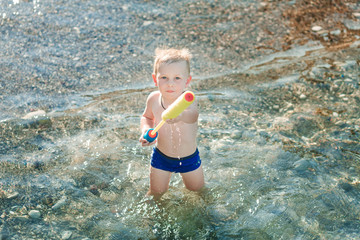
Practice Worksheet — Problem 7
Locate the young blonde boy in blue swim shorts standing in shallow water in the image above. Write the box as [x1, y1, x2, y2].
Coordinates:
[139, 49, 204, 198]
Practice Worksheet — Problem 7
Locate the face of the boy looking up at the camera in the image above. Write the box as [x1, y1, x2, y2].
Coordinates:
[153, 61, 191, 99]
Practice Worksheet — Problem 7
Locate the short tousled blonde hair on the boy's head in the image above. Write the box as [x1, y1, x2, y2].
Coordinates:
[154, 48, 192, 75]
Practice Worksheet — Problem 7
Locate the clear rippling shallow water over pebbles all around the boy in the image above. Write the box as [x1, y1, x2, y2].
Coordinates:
[0, 0, 360, 240]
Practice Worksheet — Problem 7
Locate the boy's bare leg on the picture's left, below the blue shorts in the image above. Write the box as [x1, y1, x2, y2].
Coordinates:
[147, 167, 171, 198]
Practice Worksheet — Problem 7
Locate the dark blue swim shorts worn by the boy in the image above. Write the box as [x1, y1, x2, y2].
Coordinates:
[151, 147, 201, 173]
